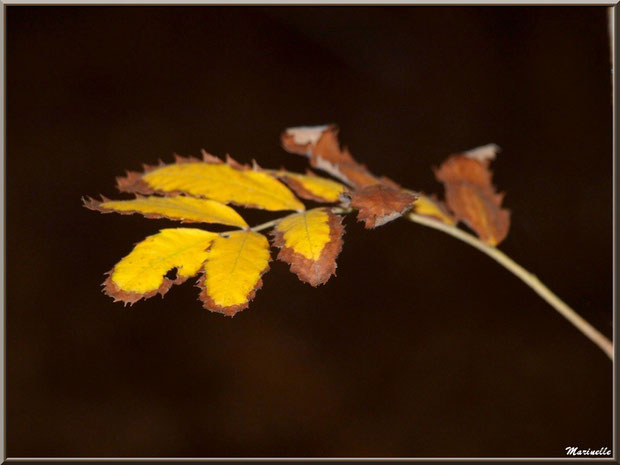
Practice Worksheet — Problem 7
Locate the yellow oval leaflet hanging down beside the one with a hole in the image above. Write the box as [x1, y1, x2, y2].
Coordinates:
[199, 231, 270, 316]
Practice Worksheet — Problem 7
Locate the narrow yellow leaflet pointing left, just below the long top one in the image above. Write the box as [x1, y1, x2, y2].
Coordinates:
[84, 195, 248, 228]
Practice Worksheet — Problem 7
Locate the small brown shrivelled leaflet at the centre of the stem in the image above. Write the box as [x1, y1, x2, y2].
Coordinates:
[351, 184, 416, 229]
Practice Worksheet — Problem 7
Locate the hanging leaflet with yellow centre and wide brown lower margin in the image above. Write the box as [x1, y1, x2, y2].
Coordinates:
[272, 208, 344, 286]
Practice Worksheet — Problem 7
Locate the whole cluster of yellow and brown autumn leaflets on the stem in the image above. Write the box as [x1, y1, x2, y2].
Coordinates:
[83, 125, 509, 316]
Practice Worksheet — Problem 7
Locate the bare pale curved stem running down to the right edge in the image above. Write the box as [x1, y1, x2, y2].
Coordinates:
[407, 213, 614, 360]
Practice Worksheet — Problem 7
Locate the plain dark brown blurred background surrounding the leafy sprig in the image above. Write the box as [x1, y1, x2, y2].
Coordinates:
[6, 6, 612, 457]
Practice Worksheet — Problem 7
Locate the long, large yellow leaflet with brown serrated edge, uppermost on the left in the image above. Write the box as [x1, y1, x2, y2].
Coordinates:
[118, 156, 305, 211]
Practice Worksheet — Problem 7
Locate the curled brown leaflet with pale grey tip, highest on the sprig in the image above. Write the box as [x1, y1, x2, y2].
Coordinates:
[281, 125, 395, 187]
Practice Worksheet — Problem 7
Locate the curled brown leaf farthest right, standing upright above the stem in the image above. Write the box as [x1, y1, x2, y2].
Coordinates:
[435, 153, 510, 245]
